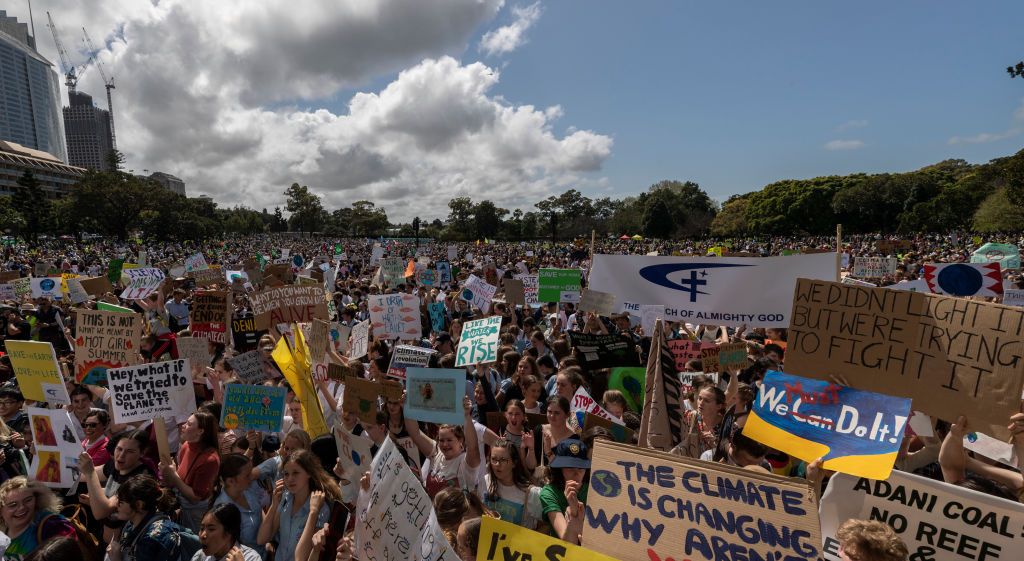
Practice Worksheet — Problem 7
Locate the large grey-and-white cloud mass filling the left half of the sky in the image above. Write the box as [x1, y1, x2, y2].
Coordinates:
[6, 0, 612, 220]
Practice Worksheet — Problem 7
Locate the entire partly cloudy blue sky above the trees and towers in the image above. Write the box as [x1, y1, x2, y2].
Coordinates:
[6, 0, 1024, 222]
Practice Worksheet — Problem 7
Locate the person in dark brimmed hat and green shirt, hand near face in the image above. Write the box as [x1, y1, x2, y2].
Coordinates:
[541, 438, 590, 545]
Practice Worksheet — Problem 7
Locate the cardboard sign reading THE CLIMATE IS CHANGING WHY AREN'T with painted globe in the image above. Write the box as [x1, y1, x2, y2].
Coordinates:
[583, 440, 821, 561]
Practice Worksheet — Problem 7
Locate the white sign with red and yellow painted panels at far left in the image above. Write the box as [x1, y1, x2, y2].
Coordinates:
[25, 407, 82, 488]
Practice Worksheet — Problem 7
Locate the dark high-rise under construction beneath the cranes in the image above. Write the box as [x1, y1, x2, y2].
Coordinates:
[63, 91, 114, 171]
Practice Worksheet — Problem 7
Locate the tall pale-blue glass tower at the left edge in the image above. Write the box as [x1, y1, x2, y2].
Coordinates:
[0, 10, 68, 164]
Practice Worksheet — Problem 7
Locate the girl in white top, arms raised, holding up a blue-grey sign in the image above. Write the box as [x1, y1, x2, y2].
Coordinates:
[406, 397, 480, 499]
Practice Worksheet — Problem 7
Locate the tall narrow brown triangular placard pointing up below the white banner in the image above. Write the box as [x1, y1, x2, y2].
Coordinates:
[639, 318, 683, 451]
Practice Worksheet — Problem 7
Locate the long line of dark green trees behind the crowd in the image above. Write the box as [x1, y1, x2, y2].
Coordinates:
[0, 150, 1024, 241]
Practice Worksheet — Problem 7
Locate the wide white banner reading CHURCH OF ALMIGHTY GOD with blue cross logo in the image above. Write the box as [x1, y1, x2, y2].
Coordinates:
[590, 253, 836, 328]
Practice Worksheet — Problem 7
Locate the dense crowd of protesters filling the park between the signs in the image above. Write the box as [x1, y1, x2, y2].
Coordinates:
[0, 233, 1024, 561]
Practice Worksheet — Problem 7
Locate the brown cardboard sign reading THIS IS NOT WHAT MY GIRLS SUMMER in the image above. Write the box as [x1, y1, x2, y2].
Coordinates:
[75, 309, 142, 385]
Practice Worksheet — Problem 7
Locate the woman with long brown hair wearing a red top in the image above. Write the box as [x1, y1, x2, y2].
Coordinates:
[160, 411, 220, 531]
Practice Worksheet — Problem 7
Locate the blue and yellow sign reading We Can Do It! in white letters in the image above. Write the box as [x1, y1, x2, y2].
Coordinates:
[743, 371, 910, 479]
